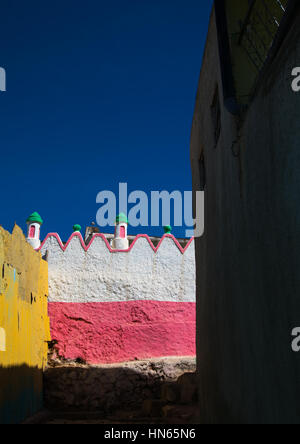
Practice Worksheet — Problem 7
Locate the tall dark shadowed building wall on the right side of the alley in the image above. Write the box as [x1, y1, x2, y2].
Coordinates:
[191, 6, 300, 423]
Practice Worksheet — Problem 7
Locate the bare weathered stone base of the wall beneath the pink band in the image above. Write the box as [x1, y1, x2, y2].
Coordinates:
[44, 357, 196, 420]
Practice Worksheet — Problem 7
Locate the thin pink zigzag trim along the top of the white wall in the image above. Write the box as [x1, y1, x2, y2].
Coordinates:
[38, 232, 194, 254]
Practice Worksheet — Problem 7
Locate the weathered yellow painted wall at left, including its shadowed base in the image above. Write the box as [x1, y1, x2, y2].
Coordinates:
[0, 226, 50, 424]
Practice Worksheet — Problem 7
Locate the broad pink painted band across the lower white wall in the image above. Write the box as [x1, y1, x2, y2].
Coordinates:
[49, 301, 196, 364]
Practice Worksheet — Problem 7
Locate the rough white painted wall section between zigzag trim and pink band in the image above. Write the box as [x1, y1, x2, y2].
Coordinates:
[41, 237, 195, 302]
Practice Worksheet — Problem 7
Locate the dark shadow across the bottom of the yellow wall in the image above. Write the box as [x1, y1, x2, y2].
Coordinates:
[0, 365, 43, 424]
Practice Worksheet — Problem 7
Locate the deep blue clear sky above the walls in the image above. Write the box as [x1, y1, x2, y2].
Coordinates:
[0, 0, 212, 239]
